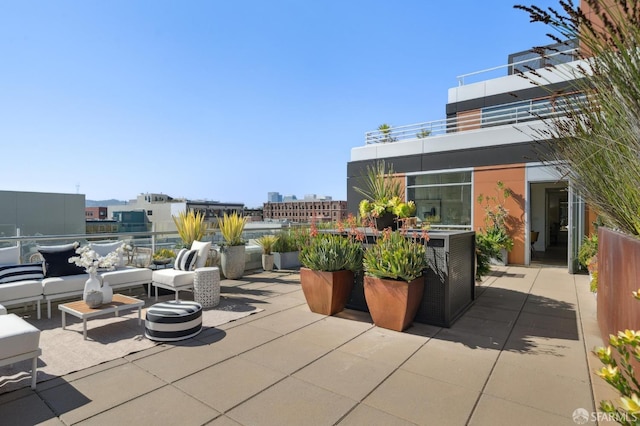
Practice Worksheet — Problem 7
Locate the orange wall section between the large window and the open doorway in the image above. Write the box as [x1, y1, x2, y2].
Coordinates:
[473, 164, 525, 265]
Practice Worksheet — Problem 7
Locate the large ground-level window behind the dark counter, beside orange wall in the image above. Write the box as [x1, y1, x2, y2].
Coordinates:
[407, 170, 473, 229]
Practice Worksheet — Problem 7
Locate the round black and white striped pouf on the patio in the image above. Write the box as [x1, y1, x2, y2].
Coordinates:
[144, 300, 202, 342]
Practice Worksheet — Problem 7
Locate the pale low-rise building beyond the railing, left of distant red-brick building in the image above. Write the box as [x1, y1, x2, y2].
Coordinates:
[108, 193, 244, 232]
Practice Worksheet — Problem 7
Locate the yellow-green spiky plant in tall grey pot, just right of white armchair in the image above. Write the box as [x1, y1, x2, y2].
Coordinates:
[218, 212, 247, 280]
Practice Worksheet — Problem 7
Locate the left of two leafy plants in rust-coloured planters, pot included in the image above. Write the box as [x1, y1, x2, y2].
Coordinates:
[300, 234, 362, 315]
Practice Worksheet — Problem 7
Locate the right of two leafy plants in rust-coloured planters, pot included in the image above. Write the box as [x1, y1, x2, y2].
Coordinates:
[363, 229, 427, 331]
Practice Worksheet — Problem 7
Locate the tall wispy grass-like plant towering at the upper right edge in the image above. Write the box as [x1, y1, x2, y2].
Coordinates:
[515, 0, 640, 235]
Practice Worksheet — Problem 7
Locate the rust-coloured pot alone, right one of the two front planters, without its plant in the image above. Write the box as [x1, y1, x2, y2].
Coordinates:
[364, 275, 424, 331]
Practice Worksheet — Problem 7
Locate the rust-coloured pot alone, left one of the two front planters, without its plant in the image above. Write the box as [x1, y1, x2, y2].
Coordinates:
[300, 268, 353, 315]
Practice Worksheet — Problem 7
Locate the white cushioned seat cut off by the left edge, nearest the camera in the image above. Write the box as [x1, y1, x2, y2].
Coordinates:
[0, 314, 42, 389]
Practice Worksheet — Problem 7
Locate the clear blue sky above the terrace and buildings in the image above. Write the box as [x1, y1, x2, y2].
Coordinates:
[0, 0, 557, 207]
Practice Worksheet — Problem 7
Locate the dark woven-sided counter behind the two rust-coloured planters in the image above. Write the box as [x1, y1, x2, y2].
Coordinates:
[347, 231, 476, 327]
